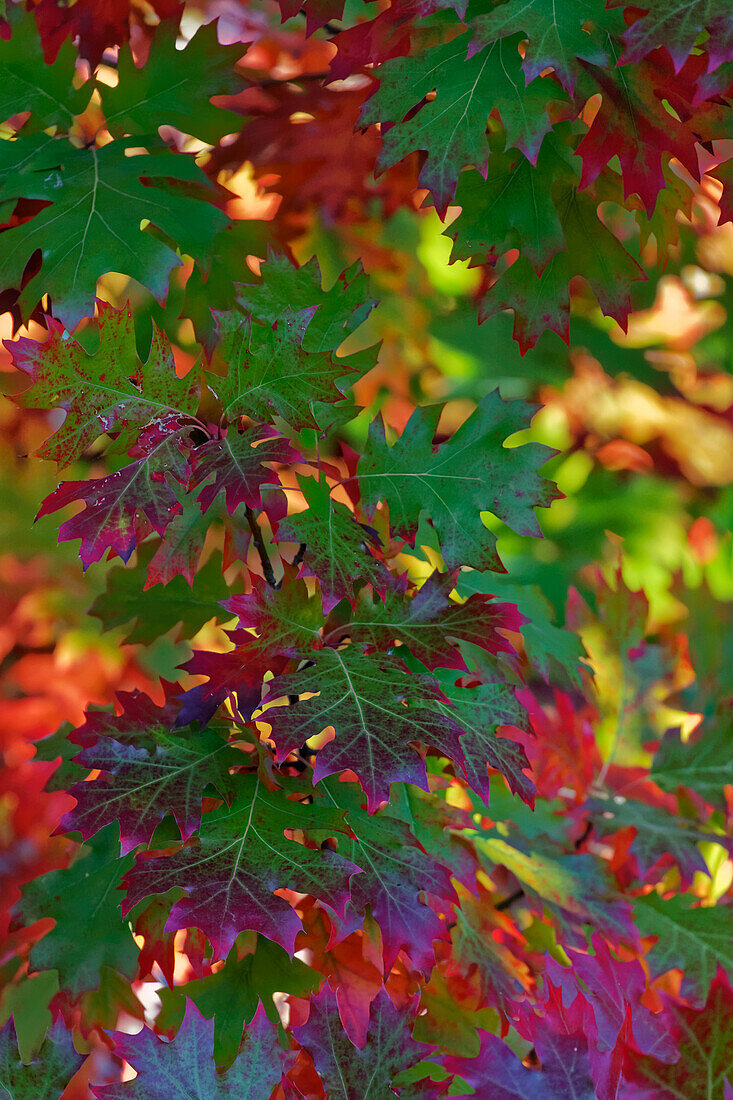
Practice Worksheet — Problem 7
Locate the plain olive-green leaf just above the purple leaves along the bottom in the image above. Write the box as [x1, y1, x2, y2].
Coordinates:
[182, 936, 314, 1066]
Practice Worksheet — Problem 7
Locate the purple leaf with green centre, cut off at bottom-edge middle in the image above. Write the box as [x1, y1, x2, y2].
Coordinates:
[294, 986, 431, 1100]
